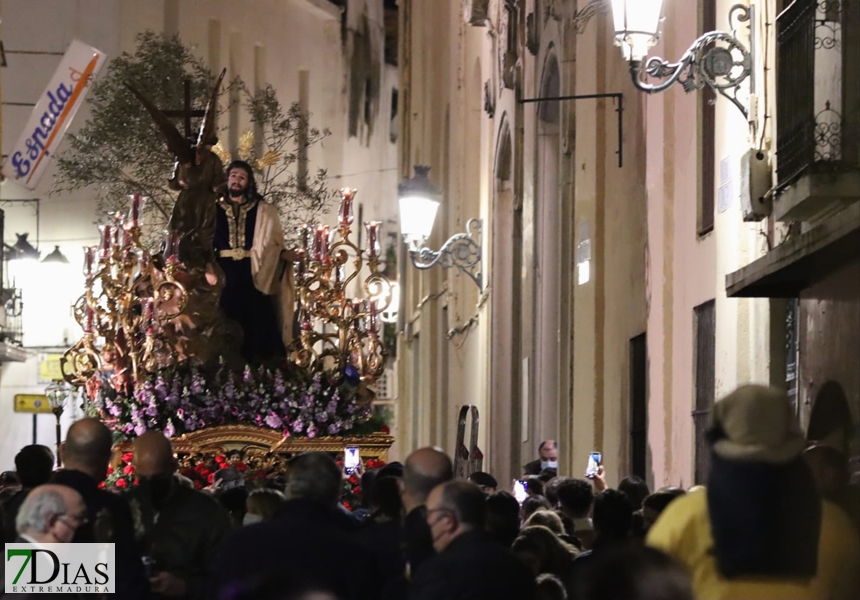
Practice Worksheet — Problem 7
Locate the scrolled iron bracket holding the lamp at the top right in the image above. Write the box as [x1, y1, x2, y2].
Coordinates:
[630, 4, 752, 120]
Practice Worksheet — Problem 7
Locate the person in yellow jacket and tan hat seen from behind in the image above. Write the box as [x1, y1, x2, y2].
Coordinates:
[647, 385, 860, 600]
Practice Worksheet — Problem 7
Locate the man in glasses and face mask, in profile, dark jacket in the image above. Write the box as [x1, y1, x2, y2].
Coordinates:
[409, 481, 535, 600]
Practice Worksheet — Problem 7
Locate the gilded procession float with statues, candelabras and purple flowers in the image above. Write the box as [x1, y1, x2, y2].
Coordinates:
[61, 73, 393, 487]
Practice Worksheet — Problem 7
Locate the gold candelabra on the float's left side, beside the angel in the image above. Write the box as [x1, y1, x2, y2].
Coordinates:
[61, 194, 188, 388]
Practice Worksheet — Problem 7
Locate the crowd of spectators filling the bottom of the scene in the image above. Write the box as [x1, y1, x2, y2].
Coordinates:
[0, 386, 860, 600]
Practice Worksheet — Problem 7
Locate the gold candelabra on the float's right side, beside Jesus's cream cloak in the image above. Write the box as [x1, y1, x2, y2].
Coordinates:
[293, 188, 392, 381]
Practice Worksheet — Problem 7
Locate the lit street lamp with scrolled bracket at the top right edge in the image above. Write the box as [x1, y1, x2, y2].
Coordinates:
[612, 0, 752, 119]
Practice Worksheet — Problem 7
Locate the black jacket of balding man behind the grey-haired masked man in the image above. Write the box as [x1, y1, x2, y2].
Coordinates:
[51, 469, 149, 600]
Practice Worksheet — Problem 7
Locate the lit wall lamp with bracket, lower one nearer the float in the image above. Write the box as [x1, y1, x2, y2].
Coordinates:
[397, 165, 483, 290]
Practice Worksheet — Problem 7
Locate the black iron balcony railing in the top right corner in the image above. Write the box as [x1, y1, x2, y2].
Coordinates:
[777, 0, 860, 189]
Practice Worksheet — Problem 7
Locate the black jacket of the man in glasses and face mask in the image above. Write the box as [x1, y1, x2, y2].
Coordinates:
[409, 531, 535, 600]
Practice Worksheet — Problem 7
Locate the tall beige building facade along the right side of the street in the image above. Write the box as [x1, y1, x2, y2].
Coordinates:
[398, 0, 860, 487]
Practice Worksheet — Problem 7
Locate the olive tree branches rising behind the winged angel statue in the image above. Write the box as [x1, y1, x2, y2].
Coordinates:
[52, 31, 333, 245]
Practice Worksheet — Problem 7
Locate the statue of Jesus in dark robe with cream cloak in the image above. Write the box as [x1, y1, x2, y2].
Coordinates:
[214, 160, 295, 363]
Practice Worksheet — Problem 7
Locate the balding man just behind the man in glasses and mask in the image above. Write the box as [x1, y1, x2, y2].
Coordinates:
[401, 447, 454, 577]
